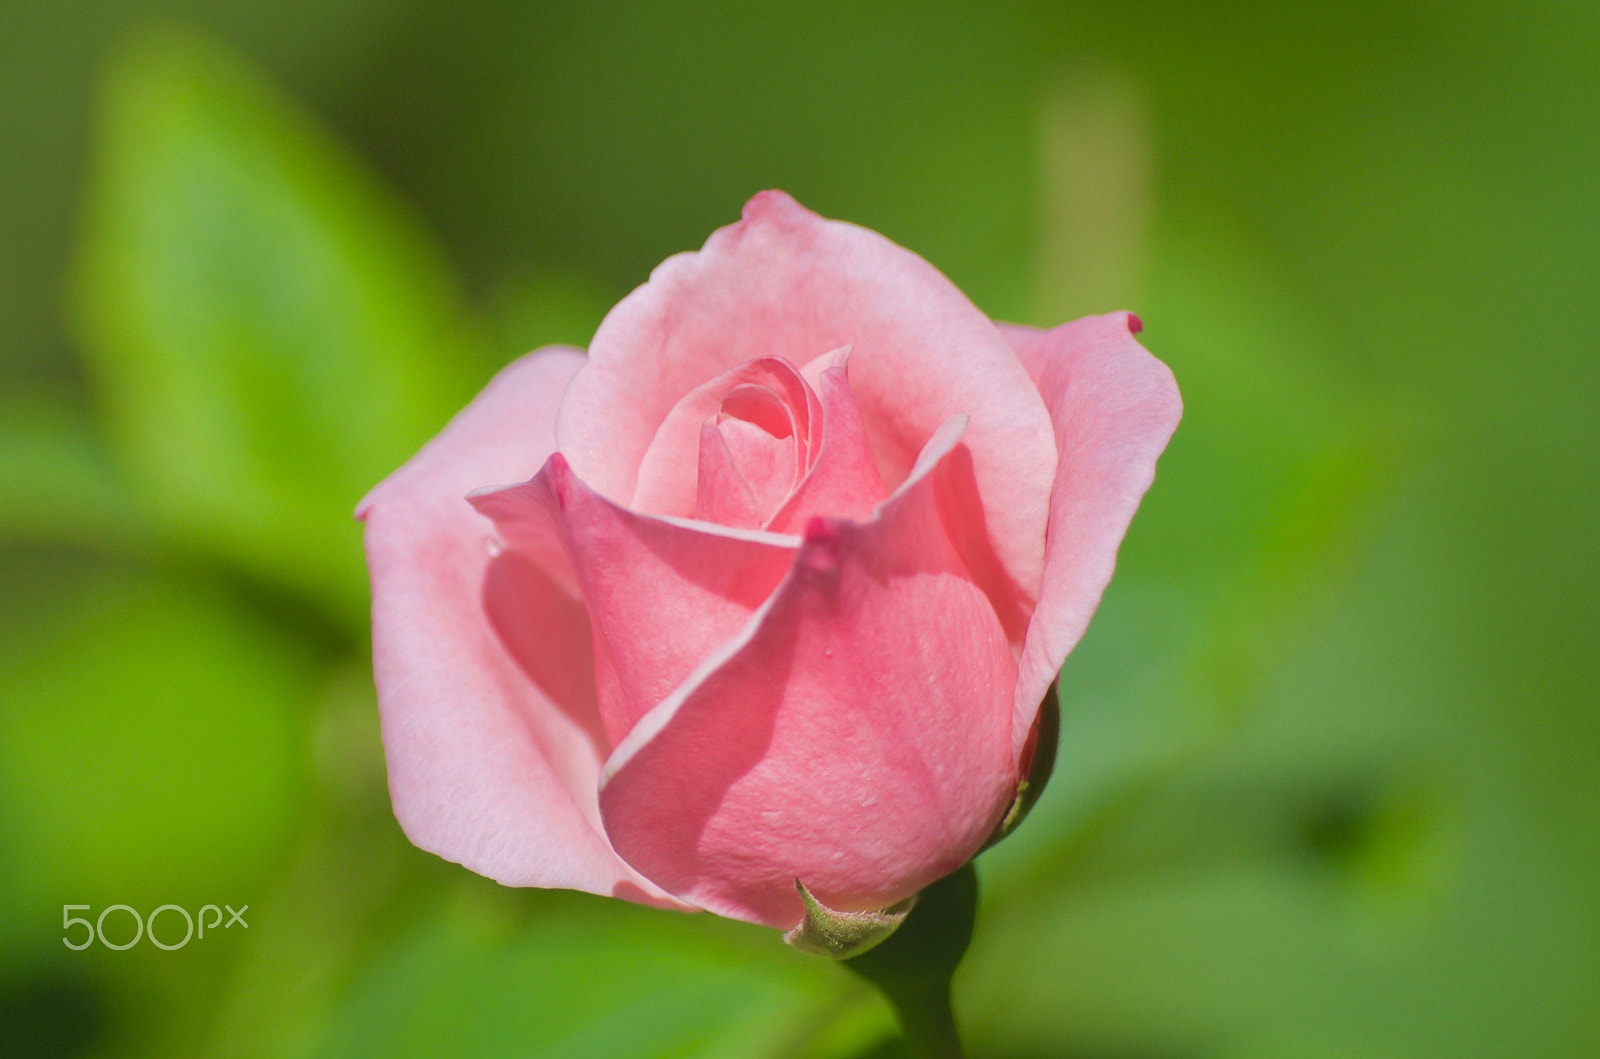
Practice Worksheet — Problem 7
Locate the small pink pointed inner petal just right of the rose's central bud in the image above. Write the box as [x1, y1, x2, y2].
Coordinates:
[770, 366, 885, 533]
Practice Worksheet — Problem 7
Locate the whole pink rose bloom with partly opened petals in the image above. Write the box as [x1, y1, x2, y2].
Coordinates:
[366, 192, 1181, 928]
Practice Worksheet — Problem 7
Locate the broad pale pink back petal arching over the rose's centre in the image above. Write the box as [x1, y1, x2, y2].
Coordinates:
[557, 192, 1056, 611]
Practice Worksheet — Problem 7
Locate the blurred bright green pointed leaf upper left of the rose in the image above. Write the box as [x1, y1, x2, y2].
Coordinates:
[77, 30, 482, 630]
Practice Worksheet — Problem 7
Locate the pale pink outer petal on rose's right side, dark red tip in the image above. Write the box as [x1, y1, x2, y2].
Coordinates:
[1002, 312, 1182, 764]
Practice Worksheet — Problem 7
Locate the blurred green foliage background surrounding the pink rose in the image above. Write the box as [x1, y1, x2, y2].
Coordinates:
[0, 0, 1600, 1059]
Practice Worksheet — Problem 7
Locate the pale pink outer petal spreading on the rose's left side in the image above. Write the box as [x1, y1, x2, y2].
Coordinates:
[357, 349, 675, 902]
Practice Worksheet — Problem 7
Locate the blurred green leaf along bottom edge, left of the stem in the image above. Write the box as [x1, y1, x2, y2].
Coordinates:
[317, 885, 893, 1059]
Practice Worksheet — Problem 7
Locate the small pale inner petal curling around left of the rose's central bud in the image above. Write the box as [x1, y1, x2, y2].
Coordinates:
[630, 357, 822, 518]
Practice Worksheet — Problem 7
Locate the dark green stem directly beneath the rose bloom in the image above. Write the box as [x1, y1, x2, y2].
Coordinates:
[845, 861, 978, 1059]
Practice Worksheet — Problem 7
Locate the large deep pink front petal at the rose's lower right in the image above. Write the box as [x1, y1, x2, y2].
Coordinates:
[600, 421, 1016, 928]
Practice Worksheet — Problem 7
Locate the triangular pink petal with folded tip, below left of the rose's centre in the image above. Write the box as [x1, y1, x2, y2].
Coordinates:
[472, 453, 798, 742]
